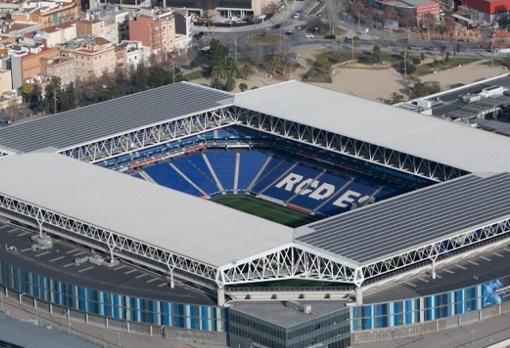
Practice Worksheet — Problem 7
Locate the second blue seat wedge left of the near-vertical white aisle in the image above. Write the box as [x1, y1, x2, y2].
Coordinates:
[172, 152, 219, 196]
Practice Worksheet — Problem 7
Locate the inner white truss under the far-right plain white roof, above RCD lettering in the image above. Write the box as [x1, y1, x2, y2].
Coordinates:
[231, 107, 467, 181]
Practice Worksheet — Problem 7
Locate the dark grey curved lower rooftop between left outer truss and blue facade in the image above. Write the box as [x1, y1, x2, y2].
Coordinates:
[0, 222, 216, 305]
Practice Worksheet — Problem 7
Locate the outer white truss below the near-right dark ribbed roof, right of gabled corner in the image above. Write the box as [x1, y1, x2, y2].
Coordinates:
[361, 218, 510, 279]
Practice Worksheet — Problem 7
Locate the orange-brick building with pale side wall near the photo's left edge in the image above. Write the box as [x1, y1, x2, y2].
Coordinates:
[10, 47, 58, 89]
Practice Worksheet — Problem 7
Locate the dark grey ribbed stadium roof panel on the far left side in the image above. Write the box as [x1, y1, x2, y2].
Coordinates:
[0, 82, 233, 152]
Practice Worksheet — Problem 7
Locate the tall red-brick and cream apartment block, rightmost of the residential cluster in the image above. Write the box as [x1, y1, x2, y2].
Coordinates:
[129, 9, 175, 54]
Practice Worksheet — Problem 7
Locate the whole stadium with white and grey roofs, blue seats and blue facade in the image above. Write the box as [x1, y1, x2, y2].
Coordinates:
[0, 81, 510, 347]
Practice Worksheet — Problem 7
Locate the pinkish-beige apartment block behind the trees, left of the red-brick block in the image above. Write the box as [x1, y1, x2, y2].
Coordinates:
[60, 37, 116, 80]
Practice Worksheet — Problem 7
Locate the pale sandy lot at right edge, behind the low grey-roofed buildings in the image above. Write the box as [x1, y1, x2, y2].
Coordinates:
[421, 61, 508, 90]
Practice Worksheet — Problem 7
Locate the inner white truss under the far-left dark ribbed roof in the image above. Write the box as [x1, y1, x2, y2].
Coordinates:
[59, 108, 234, 163]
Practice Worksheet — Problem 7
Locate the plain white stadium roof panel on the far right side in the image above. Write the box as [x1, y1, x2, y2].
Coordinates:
[234, 81, 510, 173]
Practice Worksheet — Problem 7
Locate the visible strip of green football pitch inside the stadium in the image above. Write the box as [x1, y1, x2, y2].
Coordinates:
[214, 195, 317, 227]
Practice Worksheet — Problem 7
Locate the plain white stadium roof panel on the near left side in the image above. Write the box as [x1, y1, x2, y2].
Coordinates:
[0, 153, 293, 266]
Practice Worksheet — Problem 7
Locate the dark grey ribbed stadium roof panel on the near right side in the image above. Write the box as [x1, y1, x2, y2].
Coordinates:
[296, 173, 510, 264]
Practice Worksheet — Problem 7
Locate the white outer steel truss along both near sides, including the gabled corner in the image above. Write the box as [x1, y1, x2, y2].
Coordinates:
[0, 195, 510, 288]
